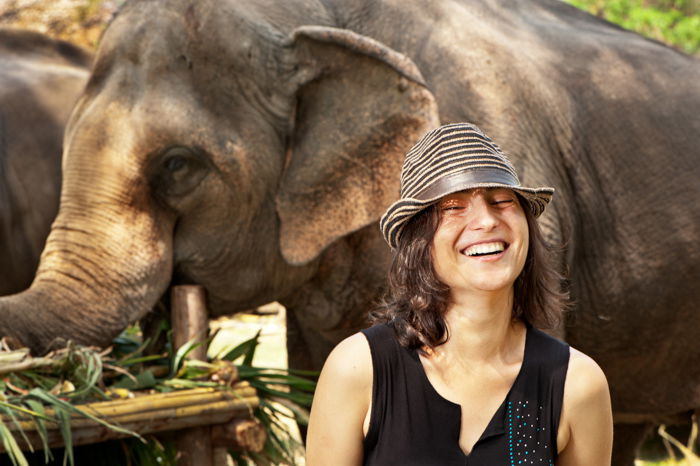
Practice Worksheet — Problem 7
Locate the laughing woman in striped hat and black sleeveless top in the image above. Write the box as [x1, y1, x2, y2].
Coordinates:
[307, 123, 612, 466]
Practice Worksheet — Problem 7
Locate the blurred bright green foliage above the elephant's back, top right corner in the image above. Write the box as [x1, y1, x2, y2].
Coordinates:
[565, 0, 700, 56]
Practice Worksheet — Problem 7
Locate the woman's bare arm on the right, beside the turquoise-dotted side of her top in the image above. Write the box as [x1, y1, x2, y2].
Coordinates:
[557, 348, 613, 466]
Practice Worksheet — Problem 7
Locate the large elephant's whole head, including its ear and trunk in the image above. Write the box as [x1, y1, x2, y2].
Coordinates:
[0, 0, 438, 351]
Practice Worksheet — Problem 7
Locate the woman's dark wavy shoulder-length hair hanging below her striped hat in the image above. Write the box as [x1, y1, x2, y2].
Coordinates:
[370, 197, 568, 352]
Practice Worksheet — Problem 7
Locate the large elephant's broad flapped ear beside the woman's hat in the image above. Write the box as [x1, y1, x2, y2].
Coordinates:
[276, 26, 439, 265]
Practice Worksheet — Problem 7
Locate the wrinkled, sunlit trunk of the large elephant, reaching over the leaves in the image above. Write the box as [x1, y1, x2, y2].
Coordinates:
[0, 118, 174, 354]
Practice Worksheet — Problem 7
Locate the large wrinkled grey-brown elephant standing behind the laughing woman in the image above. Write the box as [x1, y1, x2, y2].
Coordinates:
[0, 0, 700, 464]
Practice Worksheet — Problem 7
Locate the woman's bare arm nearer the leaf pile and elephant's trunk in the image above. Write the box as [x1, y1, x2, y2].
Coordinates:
[306, 333, 372, 466]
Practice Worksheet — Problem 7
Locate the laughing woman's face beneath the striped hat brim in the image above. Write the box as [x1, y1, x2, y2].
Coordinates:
[432, 188, 529, 296]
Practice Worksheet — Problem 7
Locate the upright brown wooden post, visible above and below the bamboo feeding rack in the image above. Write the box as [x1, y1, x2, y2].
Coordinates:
[170, 285, 214, 466]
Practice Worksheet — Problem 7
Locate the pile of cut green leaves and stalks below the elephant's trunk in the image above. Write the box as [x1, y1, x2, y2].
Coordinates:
[0, 326, 316, 466]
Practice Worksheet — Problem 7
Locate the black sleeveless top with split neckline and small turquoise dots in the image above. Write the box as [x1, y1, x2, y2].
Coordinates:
[362, 324, 569, 466]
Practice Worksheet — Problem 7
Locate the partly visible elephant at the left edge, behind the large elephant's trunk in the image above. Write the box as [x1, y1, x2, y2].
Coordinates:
[0, 28, 91, 296]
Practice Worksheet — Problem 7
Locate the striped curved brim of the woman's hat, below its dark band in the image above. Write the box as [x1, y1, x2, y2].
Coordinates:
[379, 183, 554, 249]
